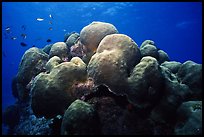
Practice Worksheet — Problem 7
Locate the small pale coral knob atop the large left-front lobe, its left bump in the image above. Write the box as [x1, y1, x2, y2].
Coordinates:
[45, 56, 62, 72]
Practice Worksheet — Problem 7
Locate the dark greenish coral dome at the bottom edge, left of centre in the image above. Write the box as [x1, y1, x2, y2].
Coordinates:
[61, 99, 100, 135]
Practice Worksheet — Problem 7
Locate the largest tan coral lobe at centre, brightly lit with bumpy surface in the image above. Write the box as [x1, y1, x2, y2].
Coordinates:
[87, 34, 141, 94]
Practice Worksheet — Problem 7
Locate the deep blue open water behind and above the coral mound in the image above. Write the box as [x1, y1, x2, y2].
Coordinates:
[2, 2, 202, 134]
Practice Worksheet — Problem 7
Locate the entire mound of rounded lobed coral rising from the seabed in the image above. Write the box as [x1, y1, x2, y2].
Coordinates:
[2, 22, 202, 135]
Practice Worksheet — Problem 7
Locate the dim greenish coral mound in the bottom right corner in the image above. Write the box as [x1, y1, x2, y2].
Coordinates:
[174, 101, 202, 135]
